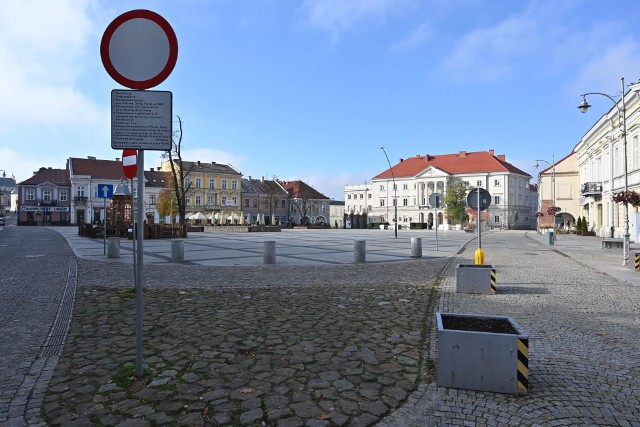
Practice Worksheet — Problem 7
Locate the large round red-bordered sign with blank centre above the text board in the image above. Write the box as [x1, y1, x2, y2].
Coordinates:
[100, 9, 178, 90]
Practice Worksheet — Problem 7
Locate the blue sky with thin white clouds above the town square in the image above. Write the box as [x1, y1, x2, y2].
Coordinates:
[0, 0, 640, 200]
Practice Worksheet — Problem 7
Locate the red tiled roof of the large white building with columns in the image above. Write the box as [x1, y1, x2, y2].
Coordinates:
[373, 151, 531, 179]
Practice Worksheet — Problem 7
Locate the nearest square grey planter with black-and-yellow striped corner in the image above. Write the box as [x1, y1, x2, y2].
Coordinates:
[436, 313, 529, 394]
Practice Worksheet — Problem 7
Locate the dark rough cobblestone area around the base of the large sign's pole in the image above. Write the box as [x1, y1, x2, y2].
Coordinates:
[43, 258, 448, 426]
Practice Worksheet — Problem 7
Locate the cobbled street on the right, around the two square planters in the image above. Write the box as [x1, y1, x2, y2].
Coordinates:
[379, 233, 640, 426]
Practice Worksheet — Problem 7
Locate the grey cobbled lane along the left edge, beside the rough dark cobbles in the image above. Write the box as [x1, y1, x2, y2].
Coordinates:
[0, 225, 75, 426]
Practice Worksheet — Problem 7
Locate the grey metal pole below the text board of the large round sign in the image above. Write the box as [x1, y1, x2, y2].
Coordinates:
[136, 150, 144, 378]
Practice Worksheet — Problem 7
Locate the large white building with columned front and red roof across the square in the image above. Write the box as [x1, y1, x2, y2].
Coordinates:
[345, 150, 537, 229]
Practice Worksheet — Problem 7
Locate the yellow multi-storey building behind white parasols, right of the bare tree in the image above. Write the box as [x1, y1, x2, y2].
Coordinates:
[161, 160, 242, 224]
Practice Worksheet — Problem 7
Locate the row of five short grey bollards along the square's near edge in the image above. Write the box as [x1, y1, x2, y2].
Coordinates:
[107, 237, 422, 265]
